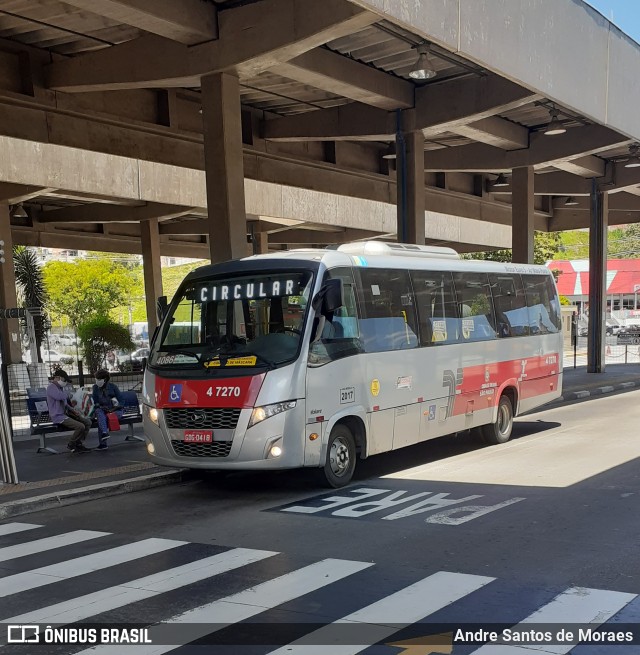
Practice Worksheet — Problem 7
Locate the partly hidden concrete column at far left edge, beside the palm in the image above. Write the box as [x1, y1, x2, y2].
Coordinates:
[0, 203, 22, 364]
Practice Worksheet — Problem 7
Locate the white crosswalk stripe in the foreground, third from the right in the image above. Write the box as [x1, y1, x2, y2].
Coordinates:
[75, 559, 373, 655]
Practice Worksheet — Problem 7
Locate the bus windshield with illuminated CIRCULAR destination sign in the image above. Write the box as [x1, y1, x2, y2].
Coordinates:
[149, 271, 314, 371]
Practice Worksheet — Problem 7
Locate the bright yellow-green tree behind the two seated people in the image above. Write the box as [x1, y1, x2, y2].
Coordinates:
[43, 259, 135, 330]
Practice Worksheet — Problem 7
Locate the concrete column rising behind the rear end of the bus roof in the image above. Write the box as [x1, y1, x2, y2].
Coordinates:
[511, 166, 535, 264]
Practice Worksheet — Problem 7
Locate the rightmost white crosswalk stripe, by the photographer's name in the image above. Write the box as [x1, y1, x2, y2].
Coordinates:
[473, 587, 637, 655]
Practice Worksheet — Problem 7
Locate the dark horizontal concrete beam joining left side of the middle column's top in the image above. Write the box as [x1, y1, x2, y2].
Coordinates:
[262, 103, 396, 141]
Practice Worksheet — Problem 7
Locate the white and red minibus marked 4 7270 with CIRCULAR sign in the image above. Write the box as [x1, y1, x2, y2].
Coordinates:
[143, 242, 562, 487]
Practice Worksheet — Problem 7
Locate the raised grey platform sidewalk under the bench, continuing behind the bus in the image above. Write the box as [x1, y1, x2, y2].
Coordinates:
[0, 357, 640, 520]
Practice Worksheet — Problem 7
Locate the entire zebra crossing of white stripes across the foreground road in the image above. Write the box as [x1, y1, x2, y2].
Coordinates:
[0, 523, 638, 655]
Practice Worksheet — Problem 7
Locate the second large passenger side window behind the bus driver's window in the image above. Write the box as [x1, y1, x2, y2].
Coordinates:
[411, 271, 460, 346]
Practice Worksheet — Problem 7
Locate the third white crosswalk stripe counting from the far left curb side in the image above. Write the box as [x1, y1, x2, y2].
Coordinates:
[0, 538, 187, 598]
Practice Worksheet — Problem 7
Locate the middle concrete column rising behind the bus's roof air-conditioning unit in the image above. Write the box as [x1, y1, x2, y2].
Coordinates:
[396, 123, 425, 246]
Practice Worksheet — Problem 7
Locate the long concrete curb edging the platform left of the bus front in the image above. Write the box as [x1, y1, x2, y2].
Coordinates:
[0, 469, 189, 520]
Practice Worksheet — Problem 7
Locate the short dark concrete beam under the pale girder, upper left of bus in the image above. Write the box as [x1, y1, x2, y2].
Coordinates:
[38, 203, 192, 224]
